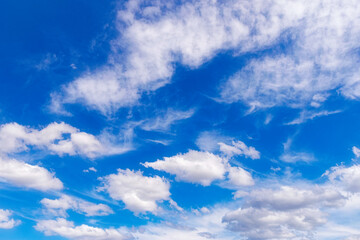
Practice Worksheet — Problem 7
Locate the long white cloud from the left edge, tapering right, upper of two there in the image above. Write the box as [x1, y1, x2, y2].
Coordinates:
[0, 123, 126, 158]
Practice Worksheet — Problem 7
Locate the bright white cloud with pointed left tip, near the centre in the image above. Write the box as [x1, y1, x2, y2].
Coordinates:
[144, 150, 226, 186]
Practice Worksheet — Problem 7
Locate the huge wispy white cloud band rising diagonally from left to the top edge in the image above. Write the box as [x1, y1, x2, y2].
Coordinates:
[52, 0, 305, 114]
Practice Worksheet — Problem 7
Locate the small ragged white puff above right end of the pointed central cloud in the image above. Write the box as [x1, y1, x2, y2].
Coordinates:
[219, 141, 260, 159]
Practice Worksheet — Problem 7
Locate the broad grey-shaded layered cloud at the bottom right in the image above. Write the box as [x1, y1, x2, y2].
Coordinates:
[223, 186, 345, 239]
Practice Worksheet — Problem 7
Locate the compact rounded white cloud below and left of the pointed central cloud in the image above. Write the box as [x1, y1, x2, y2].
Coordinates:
[100, 169, 170, 213]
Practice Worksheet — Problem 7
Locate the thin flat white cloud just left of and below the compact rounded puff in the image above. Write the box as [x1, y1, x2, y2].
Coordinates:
[41, 195, 114, 216]
